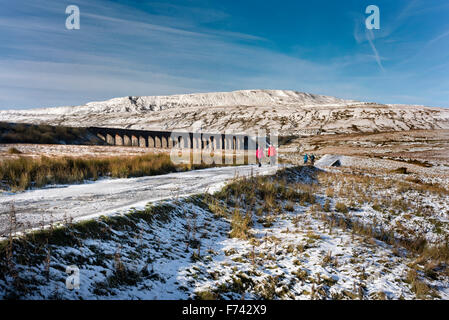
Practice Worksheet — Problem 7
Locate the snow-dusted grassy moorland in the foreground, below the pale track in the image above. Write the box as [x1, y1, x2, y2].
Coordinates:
[0, 167, 449, 299]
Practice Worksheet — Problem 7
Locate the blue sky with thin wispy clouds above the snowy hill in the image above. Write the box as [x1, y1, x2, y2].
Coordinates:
[0, 0, 449, 110]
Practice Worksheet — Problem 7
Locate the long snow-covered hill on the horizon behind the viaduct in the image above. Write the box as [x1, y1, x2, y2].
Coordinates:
[0, 90, 449, 135]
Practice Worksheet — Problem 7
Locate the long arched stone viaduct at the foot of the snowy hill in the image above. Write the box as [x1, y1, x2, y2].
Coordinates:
[88, 127, 267, 150]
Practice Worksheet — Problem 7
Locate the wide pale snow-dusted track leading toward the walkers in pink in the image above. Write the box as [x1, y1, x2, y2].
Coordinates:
[0, 165, 277, 237]
